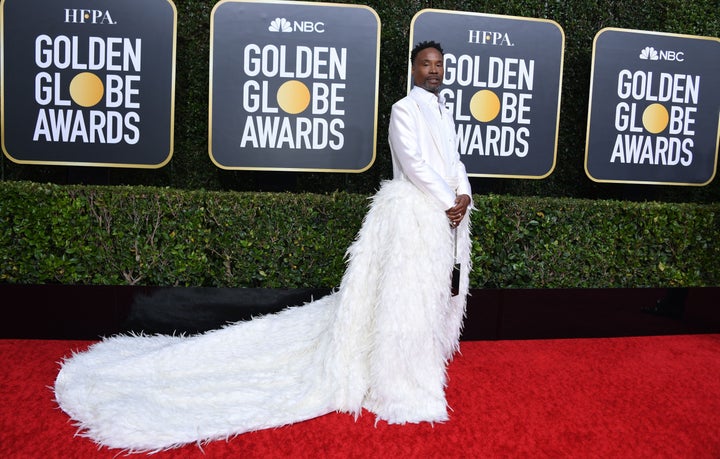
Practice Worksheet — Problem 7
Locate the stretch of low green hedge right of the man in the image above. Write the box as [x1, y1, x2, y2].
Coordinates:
[472, 196, 720, 288]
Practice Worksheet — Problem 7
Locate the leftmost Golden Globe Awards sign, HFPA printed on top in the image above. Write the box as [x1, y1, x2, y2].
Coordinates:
[2, 0, 177, 168]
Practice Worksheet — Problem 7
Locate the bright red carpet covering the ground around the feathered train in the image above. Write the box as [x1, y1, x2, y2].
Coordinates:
[0, 334, 720, 459]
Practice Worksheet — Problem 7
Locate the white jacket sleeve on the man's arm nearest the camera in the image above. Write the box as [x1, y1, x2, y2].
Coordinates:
[388, 103, 456, 210]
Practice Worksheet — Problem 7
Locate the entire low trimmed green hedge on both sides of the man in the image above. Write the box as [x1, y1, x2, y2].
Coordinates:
[0, 182, 720, 288]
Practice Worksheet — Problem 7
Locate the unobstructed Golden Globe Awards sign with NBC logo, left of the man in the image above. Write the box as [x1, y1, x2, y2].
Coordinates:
[209, 0, 380, 172]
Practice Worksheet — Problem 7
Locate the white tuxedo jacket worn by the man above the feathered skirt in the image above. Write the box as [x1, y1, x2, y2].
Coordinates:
[388, 87, 472, 210]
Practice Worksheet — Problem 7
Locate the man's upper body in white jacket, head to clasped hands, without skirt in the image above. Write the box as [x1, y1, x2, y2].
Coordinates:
[389, 41, 471, 227]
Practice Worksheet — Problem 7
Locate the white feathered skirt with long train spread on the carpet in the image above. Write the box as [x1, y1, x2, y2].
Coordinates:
[54, 180, 470, 452]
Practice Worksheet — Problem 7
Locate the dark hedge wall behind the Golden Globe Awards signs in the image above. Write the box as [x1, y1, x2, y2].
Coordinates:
[0, 0, 720, 202]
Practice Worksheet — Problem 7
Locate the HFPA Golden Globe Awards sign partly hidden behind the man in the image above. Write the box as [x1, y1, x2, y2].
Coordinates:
[410, 9, 565, 178]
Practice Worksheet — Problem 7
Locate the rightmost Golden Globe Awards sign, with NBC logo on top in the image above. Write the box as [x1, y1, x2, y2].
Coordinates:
[585, 28, 720, 186]
